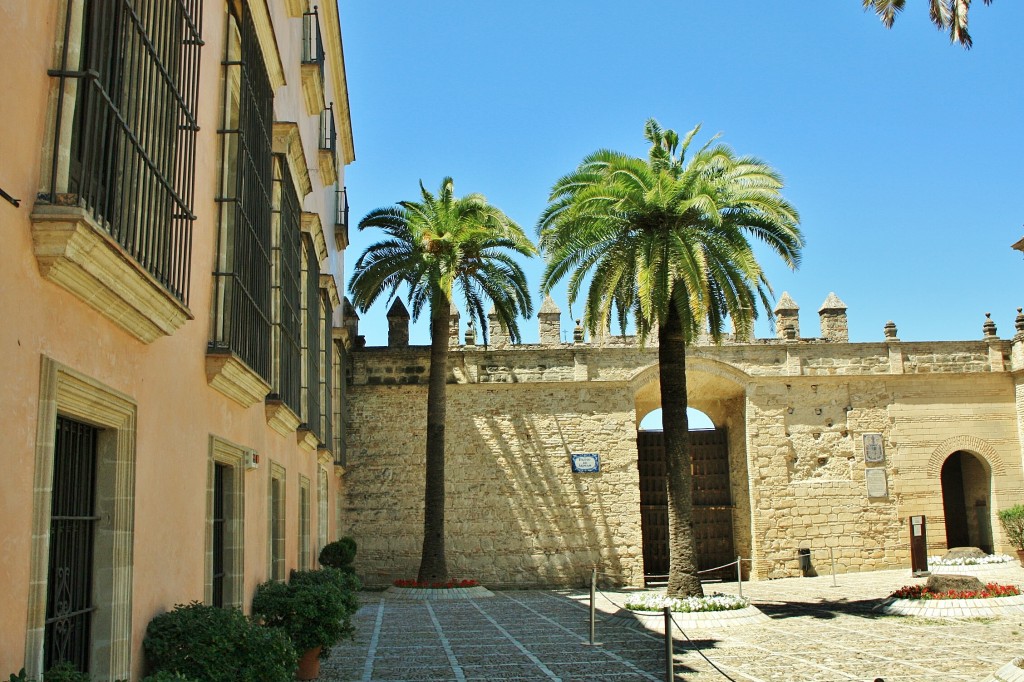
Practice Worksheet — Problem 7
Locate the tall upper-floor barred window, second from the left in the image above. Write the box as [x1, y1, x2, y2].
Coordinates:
[210, 3, 273, 381]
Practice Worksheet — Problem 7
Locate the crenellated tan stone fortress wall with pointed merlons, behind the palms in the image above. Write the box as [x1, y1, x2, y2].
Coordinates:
[341, 294, 1024, 587]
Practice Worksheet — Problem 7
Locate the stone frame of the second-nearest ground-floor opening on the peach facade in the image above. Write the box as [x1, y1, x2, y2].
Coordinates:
[203, 434, 245, 608]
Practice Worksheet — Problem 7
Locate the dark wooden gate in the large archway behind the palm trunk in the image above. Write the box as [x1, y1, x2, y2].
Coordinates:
[637, 429, 736, 582]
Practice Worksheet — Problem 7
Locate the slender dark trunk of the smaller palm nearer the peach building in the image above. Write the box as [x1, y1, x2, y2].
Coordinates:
[417, 300, 450, 583]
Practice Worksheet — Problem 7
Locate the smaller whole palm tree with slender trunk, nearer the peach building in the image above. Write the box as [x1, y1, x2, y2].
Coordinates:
[348, 177, 537, 583]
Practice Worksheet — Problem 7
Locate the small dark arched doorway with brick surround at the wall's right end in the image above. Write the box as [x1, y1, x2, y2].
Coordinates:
[940, 450, 992, 553]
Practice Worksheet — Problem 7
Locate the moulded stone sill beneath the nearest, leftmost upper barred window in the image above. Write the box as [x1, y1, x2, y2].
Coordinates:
[32, 205, 193, 343]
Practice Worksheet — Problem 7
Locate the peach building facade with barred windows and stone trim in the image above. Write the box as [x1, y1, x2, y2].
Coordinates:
[0, 0, 353, 679]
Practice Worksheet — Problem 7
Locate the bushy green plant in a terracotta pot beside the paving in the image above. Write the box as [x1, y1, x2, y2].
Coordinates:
[253, 568, 359, 680]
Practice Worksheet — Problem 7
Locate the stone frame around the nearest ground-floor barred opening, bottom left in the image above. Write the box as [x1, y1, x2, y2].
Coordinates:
[25, 355, 138, 679]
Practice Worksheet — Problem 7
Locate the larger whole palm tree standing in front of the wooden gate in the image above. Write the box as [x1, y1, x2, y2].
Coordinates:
[538, 119, 803, 596]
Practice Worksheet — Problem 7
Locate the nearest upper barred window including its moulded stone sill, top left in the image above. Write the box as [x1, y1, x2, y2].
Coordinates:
[32, 0, 203, 343]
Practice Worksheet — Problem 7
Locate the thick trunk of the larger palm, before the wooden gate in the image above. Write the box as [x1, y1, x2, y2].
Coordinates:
[657, 304, 703, 597]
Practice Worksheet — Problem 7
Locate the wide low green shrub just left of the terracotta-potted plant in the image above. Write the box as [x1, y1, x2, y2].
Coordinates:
[142, 602, 298, 682]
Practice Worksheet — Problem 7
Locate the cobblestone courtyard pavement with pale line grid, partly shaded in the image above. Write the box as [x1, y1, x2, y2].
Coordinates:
[321, 566, 1024, 682]
